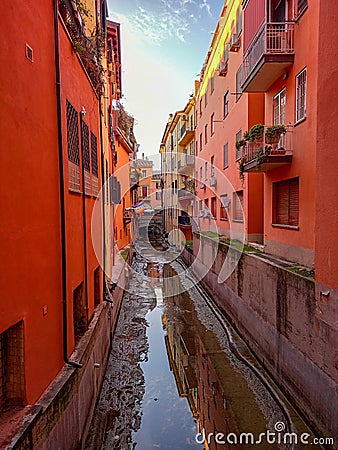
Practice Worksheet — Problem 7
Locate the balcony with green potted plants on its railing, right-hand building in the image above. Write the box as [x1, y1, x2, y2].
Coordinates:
[240, 131, 292, 172]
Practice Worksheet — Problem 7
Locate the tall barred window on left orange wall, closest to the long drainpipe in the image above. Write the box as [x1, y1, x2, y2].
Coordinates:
[66, 100, 80, 191]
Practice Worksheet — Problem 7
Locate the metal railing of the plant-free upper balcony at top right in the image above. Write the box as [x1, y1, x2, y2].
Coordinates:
[242, 22, 294, 82]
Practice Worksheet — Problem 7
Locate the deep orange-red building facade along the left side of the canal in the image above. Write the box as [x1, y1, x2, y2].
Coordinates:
[0, 0, 133, 442]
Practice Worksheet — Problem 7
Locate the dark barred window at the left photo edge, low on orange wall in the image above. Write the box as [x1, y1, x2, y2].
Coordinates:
[0, 320, 25, 412]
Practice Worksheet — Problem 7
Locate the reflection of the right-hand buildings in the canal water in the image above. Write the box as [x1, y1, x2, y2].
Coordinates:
[162, 265, 240, 450]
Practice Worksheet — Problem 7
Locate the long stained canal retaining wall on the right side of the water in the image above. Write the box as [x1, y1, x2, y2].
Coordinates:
[183, 233, 338, 448]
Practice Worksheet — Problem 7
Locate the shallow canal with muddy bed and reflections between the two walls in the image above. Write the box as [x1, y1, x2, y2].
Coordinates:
[86, 243, 312, 450]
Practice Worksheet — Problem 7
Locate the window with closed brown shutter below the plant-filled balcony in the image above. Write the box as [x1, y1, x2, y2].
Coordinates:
[272, 178, 299, 227]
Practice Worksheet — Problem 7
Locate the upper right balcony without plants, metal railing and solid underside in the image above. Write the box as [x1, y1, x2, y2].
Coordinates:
[242, 22, 294, 92]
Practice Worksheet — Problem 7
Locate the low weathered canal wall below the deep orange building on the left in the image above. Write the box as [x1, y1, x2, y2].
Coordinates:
[6, 255, 131, 450]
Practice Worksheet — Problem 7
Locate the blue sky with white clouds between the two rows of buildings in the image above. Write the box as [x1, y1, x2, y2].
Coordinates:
[108, 0, 224, 165]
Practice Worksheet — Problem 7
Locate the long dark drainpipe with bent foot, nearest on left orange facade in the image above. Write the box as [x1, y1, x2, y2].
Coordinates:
[54, 0, 82, 369]
